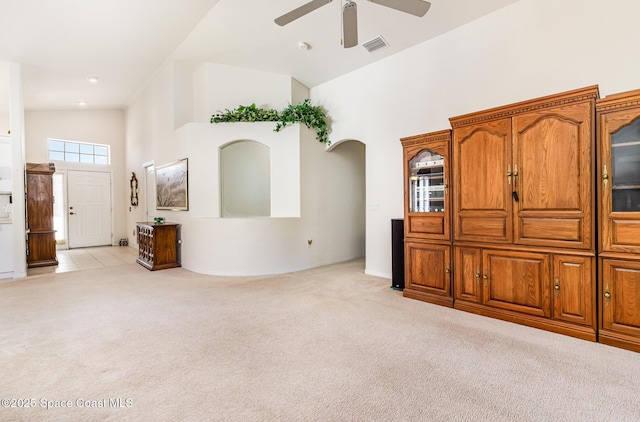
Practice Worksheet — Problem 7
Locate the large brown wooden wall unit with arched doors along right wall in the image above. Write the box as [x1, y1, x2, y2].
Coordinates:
[402, 86, 640, 352]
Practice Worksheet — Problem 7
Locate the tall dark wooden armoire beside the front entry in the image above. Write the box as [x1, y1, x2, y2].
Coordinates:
[26, 163, 58, 268]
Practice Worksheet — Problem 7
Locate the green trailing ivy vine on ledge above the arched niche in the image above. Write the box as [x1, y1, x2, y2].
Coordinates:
[211, 98, 331, 145]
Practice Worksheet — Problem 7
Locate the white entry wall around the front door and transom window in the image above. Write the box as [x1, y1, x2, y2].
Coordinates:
[25, 110, 131, 243]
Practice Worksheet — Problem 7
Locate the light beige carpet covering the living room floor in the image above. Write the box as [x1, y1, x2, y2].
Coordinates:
[0, 260, 640, 421]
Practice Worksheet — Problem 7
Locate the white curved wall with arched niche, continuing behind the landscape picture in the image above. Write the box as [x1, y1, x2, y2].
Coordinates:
[126, 63, 364, 275]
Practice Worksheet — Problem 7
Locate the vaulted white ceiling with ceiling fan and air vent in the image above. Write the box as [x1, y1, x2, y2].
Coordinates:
[0, 0, 517, 109]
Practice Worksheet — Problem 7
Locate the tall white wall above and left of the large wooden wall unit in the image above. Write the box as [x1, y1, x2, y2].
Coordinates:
[311, 0, 640, 277]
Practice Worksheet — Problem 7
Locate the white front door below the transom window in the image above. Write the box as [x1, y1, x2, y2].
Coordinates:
[67, 170, 111, 248]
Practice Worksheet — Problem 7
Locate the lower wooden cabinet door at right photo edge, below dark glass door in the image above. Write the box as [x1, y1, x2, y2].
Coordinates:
[600, 259, 640, 344]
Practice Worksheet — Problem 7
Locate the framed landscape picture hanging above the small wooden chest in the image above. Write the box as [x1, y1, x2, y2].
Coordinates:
[156, 158, 189, 211]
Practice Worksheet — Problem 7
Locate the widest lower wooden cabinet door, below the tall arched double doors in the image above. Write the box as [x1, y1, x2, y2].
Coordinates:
[482, 250, 551, 318]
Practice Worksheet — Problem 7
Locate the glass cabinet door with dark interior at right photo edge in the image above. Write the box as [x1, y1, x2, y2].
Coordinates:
[611, 120, 640, 212]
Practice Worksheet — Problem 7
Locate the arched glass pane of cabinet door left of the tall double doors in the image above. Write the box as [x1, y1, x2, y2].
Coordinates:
[409, 149, 446, 212]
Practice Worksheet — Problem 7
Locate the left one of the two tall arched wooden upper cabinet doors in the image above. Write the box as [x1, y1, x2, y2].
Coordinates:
[453, 119, 513, 243]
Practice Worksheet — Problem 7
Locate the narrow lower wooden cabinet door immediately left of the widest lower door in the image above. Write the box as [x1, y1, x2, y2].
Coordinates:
[453, 247, 482, 303]
